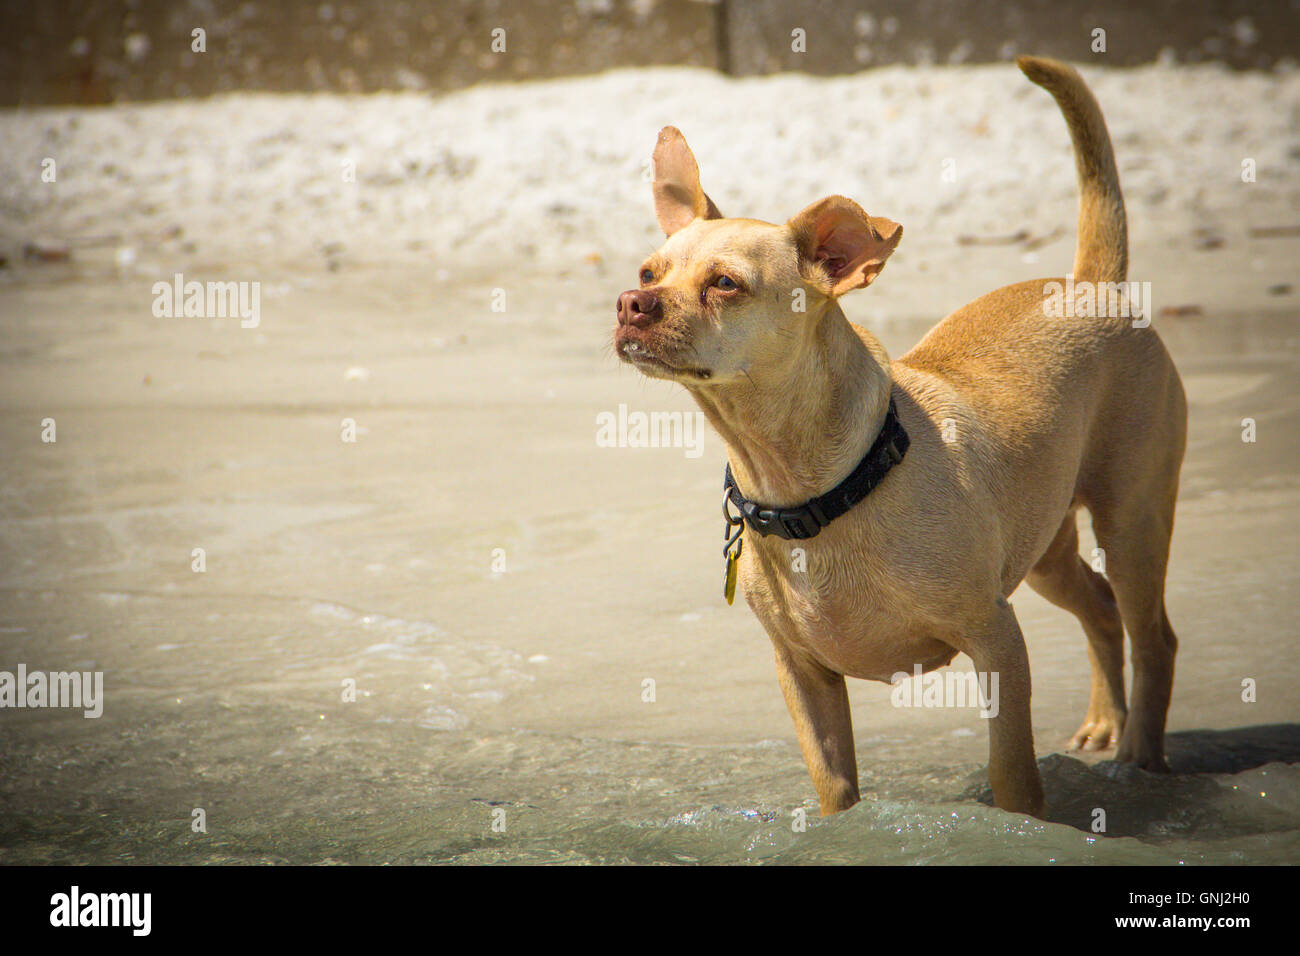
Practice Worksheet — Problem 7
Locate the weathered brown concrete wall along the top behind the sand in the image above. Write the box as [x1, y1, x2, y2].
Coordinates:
[0, 0, 1300, 105]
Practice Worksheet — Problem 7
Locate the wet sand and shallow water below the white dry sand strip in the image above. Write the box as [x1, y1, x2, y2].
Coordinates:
[0, 265, 1300, 865]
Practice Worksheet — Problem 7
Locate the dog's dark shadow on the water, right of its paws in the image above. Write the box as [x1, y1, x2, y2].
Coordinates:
[962, 723, 1300, 838]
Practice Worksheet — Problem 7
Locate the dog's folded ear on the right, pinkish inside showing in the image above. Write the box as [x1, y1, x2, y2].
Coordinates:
[788, 196, 902, 298]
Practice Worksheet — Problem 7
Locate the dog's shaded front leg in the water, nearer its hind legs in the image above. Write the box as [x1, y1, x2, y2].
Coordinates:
[963, 598, 1043, 817]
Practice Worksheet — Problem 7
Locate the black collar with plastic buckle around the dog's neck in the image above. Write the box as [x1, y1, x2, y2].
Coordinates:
[723, 398, 911, 540]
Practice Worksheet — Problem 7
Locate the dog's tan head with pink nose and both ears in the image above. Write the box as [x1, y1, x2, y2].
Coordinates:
[614, 126, 902, 388]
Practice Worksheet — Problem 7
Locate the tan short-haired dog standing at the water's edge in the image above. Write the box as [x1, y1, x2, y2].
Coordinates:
[614, 57, 1187, 814]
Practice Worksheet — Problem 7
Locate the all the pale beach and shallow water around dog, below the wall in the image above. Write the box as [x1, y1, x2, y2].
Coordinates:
[0, 65, 1300, 864]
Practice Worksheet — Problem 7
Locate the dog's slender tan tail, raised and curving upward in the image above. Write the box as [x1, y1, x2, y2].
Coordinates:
[1015, 56, 1128, 282]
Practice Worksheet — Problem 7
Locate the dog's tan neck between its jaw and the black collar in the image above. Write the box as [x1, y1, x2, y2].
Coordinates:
[689, 300, 892, 507]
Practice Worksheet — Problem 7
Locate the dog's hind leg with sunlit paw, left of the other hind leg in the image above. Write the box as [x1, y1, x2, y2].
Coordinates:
[1024, 511, 1126, 750]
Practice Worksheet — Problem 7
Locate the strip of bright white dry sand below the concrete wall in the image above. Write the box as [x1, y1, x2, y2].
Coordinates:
[0, 64, 1300, 278]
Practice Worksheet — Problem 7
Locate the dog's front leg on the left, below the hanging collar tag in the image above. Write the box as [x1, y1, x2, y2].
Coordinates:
[776, 644, 861, 817]
